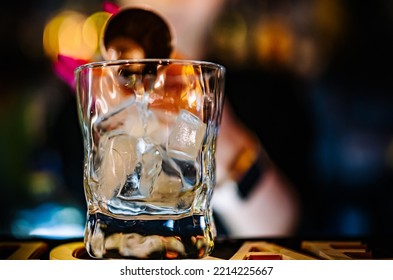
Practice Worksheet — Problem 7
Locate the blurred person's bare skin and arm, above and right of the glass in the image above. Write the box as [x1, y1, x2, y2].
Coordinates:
[113, 0, 301, 238]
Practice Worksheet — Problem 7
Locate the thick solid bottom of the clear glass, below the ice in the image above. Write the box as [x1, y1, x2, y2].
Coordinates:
[85, 213, 215, 259]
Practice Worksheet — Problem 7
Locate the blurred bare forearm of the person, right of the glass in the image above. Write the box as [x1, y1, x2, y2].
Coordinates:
[212, 101, 300, 238]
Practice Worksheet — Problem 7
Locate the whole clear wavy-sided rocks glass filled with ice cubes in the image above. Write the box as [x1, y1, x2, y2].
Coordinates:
[75, 59, 225, 259]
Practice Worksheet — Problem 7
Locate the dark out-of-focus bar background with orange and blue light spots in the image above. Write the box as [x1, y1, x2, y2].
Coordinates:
[0, 0, 393, 238]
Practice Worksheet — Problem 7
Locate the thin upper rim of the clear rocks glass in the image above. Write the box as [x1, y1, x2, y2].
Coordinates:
[74, 58, 226, 74]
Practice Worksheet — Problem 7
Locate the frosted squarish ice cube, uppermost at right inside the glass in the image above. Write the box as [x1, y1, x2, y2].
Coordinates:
[167, 110, 206, 160]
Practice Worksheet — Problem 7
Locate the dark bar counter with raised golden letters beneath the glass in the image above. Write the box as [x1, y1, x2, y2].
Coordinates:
[0, 237, 393, 260]
